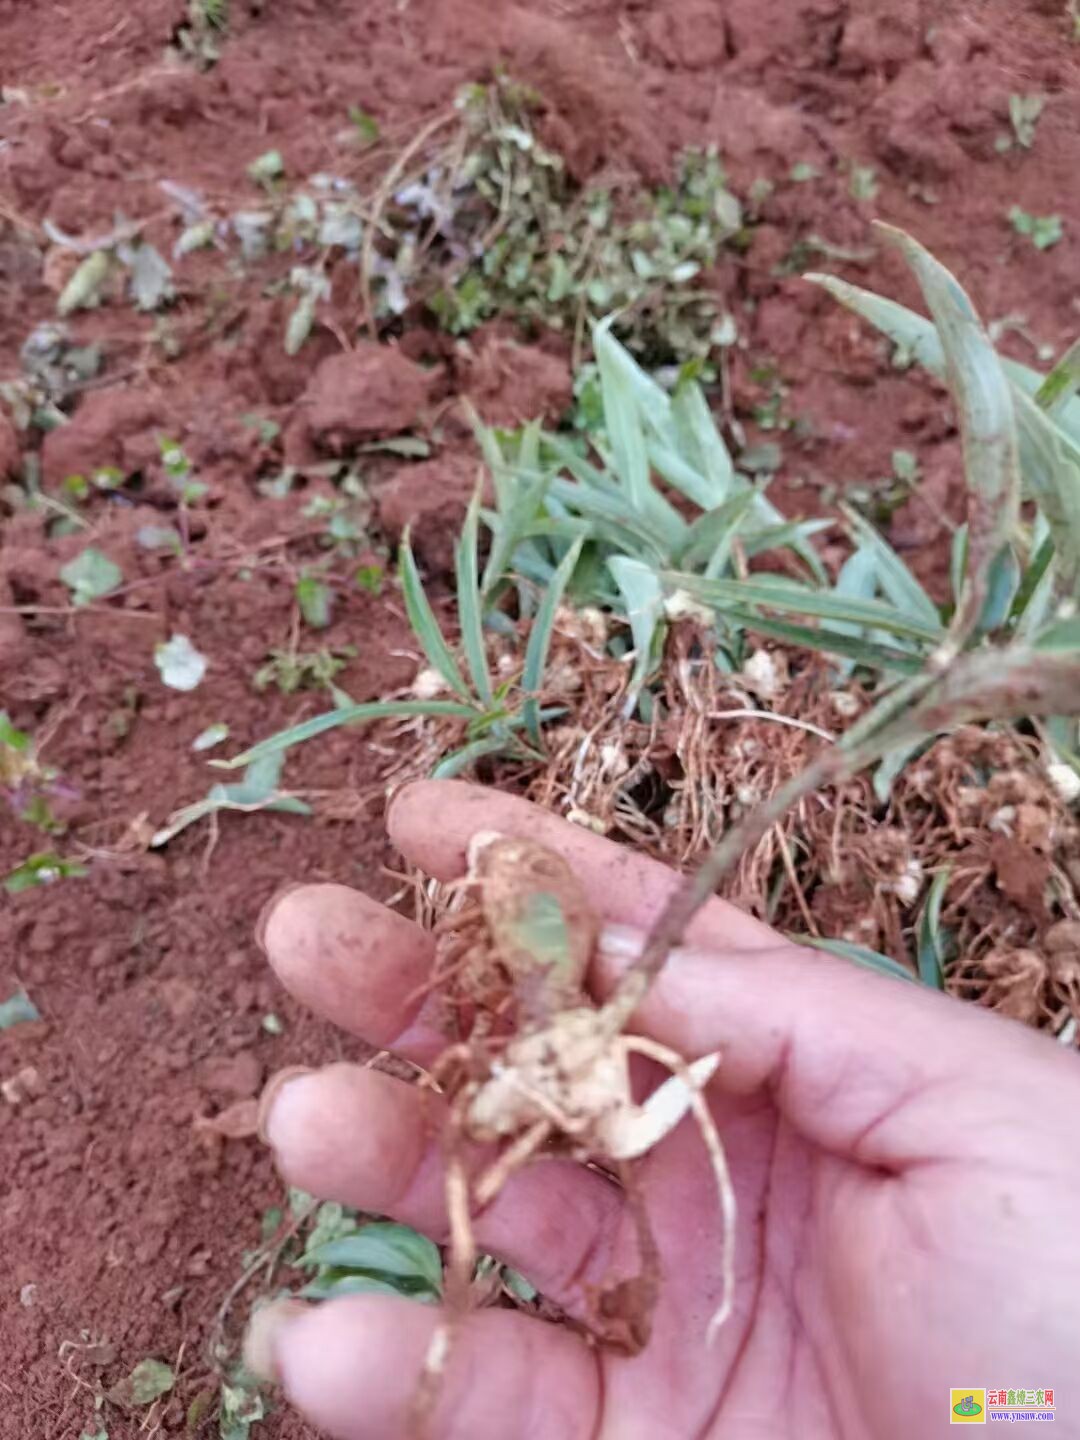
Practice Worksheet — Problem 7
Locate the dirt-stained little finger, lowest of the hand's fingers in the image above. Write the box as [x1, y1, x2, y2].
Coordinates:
[272, 1295, 600, 1440]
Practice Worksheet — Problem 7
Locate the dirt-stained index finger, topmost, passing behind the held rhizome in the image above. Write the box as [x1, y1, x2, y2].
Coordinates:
[387, 780, 778, 950]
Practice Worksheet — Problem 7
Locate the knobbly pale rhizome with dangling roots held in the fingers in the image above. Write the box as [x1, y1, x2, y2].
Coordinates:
[416, 834, 734, 1430]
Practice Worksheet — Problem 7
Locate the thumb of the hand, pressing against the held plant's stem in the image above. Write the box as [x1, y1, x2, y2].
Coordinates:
[593, 926, 1080, 1171]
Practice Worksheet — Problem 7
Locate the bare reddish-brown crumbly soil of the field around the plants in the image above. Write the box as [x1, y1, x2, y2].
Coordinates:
[0, 0, 1080, 1440]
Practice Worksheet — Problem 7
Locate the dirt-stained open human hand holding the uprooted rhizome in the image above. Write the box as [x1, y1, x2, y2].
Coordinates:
[249, 782, 1080, 1440]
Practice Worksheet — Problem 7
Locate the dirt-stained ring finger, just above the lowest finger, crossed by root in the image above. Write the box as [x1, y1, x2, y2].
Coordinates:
[262, 1064, 624, 1309]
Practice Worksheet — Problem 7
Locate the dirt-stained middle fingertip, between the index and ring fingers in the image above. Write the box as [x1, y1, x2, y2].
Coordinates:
[259, 884, 444, 1064]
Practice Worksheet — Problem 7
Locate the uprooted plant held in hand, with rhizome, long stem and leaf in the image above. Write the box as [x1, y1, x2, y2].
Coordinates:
[403, 232, 1080, 1418]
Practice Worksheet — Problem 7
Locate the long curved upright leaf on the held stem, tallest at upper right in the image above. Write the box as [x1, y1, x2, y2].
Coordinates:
[878, 226, 1020, 649]
